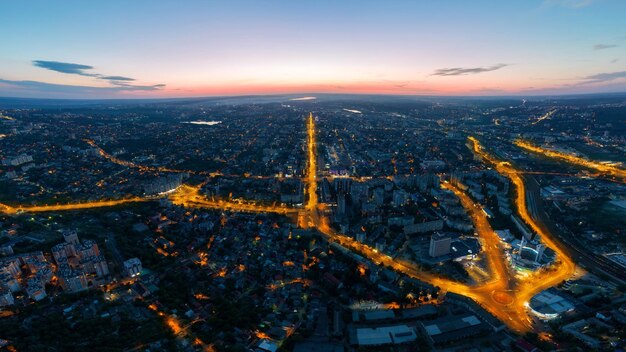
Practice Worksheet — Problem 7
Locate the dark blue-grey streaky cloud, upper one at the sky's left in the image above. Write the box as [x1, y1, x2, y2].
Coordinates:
[31, 60, 165, 90]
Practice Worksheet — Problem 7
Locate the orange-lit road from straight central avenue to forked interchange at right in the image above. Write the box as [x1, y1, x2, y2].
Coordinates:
[298, 114, 575, 332]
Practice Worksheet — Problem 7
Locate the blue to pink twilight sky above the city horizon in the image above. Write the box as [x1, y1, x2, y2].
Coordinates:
[0, 0, 626, 99]
